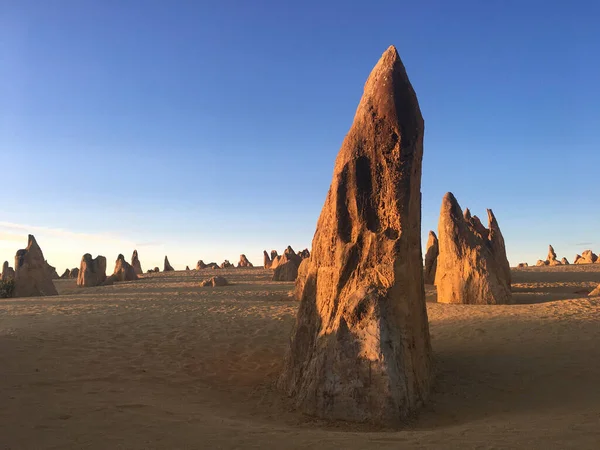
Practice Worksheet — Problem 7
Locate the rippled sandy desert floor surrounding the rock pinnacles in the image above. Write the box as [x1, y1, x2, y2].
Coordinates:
[0, 264, 600, 450]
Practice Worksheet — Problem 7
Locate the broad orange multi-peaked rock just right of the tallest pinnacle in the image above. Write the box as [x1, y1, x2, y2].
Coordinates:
[435, 192, 512, 305]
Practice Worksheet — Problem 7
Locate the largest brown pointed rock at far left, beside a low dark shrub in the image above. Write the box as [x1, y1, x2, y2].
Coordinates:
[13, 234, 58, 297]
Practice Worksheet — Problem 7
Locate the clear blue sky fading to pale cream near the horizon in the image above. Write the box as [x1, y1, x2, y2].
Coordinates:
[0, 0, 600, 271]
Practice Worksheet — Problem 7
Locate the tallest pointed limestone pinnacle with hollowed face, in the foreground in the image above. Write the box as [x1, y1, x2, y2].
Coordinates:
[278, 47, 431, 424]
